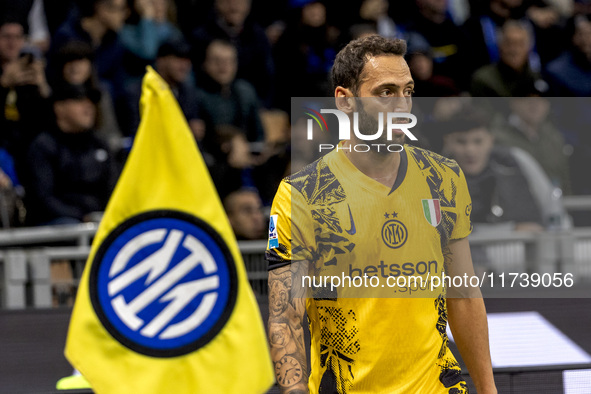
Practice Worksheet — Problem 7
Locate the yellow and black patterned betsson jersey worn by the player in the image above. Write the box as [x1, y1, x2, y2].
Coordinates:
[266, 146, 471, 394]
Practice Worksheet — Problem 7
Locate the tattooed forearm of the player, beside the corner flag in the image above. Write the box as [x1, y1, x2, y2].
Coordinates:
[269, 263, 308, 394]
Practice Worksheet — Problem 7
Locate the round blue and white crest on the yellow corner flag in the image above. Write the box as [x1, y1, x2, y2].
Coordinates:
[90, 211, 237, 357]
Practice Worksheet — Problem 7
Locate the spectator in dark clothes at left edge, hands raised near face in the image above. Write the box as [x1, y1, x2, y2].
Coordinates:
[0, 19, 51, 178]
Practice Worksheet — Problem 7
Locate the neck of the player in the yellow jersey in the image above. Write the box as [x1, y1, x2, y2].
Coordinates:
[341, 140, 400, 187]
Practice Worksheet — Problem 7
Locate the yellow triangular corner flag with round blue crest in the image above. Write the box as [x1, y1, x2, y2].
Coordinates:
[65, 68, 274, 394]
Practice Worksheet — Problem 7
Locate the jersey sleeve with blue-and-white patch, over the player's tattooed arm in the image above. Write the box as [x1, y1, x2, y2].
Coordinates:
[265, 180, 314, 270]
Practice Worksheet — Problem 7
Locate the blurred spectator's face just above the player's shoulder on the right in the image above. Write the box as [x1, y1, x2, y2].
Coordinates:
[445, 127, 494, 175]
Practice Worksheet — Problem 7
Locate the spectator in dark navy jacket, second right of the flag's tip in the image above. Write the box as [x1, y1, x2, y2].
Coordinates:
[198, 40, 264, 148]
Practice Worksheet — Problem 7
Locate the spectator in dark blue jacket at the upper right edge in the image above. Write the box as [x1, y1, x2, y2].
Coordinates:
[545, 15, 591, 97]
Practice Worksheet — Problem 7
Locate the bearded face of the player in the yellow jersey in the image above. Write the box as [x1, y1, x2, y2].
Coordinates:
[355, 55, 414, 144]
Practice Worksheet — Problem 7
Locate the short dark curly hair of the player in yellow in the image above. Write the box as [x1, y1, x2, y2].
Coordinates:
[330, 35, 406, 92]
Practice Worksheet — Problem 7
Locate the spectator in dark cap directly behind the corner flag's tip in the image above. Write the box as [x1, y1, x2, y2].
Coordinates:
[127, 39, 205, 142]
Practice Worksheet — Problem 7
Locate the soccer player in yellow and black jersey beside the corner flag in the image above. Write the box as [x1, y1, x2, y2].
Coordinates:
[266, 36, 496, 394]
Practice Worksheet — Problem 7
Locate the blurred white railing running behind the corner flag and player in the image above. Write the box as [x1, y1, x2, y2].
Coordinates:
[0, 224, 591, 309]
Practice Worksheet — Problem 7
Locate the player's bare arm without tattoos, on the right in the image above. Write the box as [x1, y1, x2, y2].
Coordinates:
[444, 238, 497, 394]
